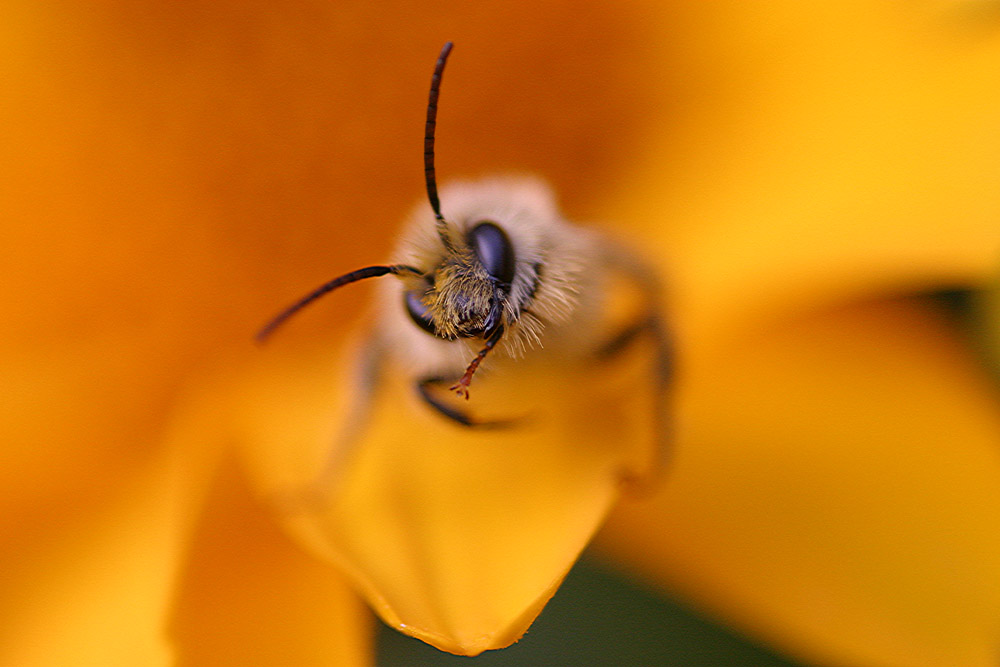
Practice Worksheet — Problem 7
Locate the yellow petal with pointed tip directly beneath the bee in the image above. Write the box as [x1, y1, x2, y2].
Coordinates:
[240, 336, 650, 655]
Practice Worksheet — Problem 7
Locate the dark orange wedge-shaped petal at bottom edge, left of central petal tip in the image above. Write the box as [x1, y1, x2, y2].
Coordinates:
[171, 454, 372, 667]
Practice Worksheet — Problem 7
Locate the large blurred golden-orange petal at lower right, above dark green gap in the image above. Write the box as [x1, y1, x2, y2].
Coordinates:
[602, 301, 1000, 666]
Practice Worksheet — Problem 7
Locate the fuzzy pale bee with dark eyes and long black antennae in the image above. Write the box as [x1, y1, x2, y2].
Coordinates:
[257, 42, 671, 448]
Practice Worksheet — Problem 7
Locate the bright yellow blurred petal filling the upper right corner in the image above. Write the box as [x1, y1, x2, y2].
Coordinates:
[606, 0, 1000, 340]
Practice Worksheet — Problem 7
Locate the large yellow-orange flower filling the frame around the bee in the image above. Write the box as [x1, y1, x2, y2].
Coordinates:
[0, 2, 1000, 665]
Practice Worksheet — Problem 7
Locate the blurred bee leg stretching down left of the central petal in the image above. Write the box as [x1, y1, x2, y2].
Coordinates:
[272, 335, 384, 515]
